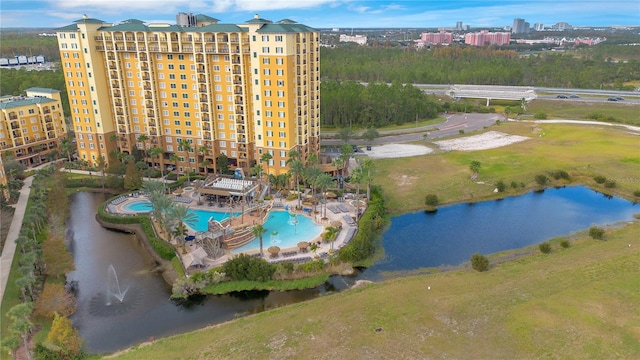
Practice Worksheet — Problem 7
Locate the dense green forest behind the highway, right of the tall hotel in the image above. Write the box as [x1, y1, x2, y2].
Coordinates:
[320, 45, 640, 89]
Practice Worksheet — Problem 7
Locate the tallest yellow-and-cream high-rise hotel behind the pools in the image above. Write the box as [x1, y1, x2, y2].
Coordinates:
[57, 14, 320, 175]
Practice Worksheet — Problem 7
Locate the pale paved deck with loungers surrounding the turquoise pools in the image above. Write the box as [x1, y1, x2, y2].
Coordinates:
[108, 187, 364, 272]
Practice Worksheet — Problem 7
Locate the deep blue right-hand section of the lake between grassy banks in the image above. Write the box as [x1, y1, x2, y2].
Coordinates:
[365, 186, 640, 280]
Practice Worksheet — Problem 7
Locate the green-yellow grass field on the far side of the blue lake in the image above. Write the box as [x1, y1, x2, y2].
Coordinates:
[374, 122, 640, 214]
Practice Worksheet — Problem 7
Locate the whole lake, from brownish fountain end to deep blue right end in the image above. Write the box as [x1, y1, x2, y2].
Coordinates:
[67, 187, 640, 353]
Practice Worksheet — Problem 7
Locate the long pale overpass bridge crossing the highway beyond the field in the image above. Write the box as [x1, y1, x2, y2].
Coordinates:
[445, 85, 537, 106]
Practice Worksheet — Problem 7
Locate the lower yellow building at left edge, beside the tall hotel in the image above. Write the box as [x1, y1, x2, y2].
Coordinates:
[0, 88, 67, 167]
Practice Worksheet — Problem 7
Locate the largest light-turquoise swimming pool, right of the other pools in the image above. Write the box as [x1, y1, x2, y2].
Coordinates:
[233, 211, 323, 254]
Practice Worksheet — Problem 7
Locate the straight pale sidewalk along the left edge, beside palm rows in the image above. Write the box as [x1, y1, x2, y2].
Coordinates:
[0, 176, 33, 303]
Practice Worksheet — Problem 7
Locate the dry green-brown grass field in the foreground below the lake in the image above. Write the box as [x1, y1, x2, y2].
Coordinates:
[106, 221, 640, 360]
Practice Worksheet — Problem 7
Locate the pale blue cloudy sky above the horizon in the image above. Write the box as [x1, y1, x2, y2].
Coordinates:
[0, 0, 640, 28]
